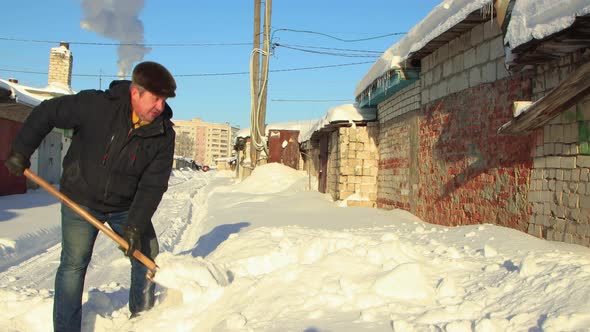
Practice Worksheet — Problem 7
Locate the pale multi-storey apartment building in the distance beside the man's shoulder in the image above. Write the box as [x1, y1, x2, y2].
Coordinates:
[172, 118, 239, 165]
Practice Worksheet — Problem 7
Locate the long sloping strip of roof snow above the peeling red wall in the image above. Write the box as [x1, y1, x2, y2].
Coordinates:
[354, 0, 490, 96]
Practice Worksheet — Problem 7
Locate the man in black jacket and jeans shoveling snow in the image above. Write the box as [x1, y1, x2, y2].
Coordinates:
[5, 62, 176, 332]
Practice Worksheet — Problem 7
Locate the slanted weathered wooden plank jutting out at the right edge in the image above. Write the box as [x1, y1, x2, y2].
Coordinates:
[498, 61, 590, 135]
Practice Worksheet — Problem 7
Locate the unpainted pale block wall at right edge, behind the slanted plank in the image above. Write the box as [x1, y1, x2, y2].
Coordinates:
[528, 51, 590, 246]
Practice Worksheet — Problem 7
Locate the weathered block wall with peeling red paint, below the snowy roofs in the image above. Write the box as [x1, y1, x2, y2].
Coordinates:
[377, 16, 590, 246]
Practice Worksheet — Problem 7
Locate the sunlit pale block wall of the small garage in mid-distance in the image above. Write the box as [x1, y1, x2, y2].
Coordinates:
[327, 122, 379, 207]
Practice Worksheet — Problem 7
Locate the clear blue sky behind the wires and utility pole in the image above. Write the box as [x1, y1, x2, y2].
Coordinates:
[0, 0, 440, 128]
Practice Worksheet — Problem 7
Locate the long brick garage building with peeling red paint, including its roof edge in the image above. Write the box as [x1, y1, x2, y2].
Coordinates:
[356, 1, 590, 246]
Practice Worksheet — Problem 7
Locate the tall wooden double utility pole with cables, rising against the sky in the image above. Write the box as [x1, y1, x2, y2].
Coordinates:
[250, 0, 272, 169]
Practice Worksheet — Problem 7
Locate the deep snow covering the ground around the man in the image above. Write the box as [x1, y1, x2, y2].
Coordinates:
[0, 164, 590, 332]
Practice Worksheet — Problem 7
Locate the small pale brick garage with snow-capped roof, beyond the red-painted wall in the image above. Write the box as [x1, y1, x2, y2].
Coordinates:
[300, 104, 379, 207]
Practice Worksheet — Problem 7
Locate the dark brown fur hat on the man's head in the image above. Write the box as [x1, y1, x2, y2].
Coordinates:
[131, 61, 176, 97]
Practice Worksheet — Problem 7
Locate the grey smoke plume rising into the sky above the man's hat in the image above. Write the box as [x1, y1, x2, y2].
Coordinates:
[80, 0, 151, 78]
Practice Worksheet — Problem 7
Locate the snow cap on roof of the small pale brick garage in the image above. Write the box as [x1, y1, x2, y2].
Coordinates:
[299, 104, 377, 142]
